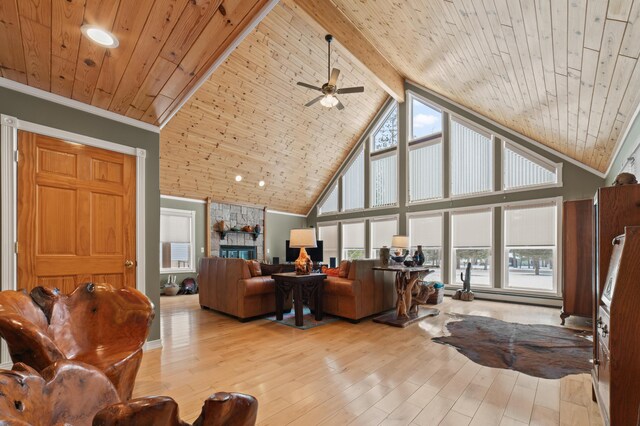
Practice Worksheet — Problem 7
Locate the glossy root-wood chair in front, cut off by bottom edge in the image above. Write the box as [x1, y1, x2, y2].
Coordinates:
[0, 360, 258, 426]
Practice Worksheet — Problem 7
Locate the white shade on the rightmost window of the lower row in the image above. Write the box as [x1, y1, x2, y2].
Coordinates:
[504, 203, 557, 247]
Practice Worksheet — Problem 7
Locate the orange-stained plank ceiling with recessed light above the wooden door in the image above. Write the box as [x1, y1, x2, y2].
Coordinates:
[0, 0, 269, 125]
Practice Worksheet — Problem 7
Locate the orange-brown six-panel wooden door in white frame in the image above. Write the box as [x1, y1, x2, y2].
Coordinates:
[17, 131, 136, 293]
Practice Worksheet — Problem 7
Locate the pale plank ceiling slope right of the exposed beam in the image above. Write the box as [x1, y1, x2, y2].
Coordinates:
[332, 0, 640, 172]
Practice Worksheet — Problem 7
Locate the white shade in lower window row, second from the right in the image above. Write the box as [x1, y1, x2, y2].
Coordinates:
[451, 210, 492, 247]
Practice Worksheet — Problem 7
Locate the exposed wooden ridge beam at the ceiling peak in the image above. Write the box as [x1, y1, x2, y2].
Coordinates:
[293, 0, 404, 102]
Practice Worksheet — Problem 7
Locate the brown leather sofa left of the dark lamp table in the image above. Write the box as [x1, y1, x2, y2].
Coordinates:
[198, 257, 291, 319]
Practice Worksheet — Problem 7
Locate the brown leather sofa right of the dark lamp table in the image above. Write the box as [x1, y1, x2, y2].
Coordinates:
[323, 259, 396, 321]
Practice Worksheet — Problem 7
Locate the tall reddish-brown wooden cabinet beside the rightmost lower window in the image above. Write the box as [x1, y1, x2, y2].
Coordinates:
[560, 199, 593, 325]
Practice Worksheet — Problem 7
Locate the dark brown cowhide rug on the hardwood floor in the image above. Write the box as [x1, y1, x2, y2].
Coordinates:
[431, 315, 593, 379]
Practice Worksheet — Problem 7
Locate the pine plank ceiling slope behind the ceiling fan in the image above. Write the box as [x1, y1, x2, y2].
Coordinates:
[160, 0, 387, 214]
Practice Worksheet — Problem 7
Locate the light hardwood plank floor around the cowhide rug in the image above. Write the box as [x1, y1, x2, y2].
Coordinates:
[134, 296, 602, 426]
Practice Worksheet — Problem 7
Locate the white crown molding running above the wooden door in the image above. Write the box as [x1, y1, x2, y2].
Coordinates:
[0, 77, 160, 133]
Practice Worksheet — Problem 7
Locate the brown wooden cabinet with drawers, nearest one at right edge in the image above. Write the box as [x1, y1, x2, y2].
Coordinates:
[592, 226, 640, 426]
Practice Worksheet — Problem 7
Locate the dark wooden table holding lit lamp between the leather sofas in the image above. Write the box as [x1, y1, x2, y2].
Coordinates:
[271, 272, 327, 327]
